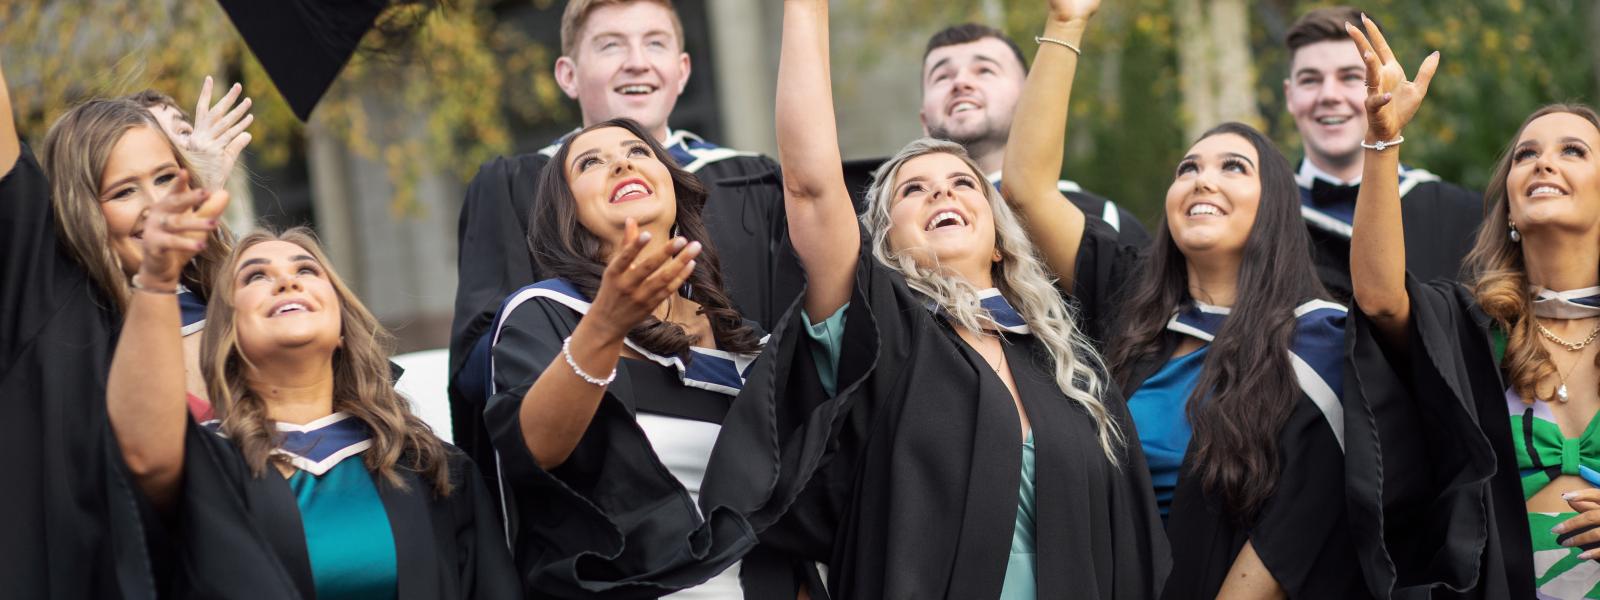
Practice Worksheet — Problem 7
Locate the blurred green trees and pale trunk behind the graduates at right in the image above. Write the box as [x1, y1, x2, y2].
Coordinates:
[834, 0, 1600, 226]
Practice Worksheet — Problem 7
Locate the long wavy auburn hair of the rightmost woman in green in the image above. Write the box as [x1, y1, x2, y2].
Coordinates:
[1466, 104, 1600, 403]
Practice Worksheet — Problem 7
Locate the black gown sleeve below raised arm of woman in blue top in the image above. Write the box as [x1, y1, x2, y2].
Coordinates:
[1070, 219, 1142, 346]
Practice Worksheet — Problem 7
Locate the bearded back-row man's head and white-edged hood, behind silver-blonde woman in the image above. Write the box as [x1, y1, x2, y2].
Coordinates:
[920, 22, 1150, 246]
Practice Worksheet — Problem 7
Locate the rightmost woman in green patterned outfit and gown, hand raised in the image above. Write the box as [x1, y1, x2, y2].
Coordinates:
[1349, 12, 1600, 598]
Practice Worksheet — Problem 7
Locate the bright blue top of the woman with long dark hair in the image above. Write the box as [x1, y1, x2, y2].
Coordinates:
[1128, 346, 1210, 520]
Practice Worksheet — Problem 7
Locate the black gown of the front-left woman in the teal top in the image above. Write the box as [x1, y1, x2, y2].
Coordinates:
[150, 421, 522, 600]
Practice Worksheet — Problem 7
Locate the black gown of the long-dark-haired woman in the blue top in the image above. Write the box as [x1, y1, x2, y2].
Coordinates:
[1074, 222, 1366, 598]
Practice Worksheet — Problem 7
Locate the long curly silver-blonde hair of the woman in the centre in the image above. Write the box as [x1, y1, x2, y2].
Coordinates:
[861, 138, 1125, 466]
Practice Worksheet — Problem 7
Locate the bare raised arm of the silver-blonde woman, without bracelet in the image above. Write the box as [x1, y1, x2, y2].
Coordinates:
[778, 0, 861, 320]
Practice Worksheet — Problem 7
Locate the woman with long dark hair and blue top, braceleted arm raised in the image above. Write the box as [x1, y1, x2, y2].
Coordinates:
[1003, 0, 1363, 598]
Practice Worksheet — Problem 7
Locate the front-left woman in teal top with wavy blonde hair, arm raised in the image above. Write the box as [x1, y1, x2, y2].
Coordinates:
[106, 227, 518, 600]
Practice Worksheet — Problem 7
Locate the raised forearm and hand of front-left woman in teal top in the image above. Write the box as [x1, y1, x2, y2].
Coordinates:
[106, 176, 227, 507]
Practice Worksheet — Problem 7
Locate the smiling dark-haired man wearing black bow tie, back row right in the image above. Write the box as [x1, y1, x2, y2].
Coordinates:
[1283, 6, 1483, 302]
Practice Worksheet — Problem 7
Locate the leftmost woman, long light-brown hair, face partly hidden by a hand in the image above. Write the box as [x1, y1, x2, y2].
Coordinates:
[0, 64, 236, 597]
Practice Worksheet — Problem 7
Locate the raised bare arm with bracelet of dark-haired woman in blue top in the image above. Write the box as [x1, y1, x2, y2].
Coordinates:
[1000, 0, 1099, 290]
